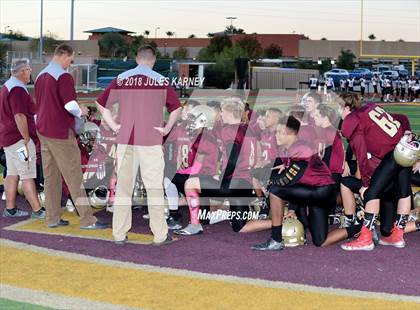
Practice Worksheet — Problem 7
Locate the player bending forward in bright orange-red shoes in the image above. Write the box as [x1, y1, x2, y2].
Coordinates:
[341, 94, 411, 251]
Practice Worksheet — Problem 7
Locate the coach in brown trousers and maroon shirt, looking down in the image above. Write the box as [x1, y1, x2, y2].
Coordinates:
[35, 44, 107, 230]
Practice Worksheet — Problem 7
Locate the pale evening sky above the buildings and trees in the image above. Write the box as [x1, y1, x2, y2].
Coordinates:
[0, 0, 420, 41]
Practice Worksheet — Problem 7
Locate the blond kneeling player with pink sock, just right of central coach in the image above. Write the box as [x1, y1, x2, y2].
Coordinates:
[175, 97, 256, 235]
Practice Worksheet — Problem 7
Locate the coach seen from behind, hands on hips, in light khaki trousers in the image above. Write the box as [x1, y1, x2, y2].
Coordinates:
[97, 45, 181, 245]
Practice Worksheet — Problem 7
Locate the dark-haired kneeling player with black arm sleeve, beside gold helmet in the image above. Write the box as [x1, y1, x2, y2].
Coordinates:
[252, 116, 335, 251]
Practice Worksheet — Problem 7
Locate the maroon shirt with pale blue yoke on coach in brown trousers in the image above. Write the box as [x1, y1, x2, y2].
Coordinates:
[35, 61, 77, 139]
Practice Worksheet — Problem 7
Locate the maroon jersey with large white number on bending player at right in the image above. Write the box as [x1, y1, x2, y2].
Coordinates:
[342, 104, 404, 187]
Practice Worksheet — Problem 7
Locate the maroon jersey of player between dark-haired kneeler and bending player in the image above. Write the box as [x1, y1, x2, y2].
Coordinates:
[316, 126, 345, 174]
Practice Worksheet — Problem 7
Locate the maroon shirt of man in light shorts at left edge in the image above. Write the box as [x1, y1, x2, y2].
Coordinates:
[0, 77, 38, 147]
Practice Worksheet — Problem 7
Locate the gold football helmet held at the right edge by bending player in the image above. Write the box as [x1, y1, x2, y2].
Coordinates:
[394, 135, 420, 167]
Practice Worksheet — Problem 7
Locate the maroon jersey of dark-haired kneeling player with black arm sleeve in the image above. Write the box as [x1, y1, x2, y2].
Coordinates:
[279, 140, 334, 186]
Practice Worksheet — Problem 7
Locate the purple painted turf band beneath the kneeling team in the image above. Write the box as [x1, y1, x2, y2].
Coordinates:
[0, 200, 420, 296]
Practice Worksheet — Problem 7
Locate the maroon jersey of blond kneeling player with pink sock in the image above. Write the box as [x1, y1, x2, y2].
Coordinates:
[220, 124, 257, 182]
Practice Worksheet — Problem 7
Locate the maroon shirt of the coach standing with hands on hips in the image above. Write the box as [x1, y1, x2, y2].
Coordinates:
[97, 65, 181, 146]
